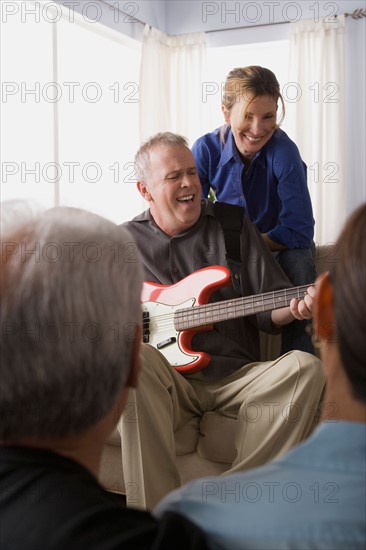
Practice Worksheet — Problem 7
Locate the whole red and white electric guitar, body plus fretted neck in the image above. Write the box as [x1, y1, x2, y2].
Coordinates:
[142, 266, 311, 374]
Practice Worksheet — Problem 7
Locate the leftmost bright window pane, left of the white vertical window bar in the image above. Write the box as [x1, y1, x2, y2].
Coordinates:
[1, 2, 55, 207]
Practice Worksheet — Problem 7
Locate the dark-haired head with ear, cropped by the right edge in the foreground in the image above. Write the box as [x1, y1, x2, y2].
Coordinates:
[314, 204, 366, 403]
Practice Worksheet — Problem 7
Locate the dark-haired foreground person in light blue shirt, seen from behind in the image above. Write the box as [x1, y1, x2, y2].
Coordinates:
[155, 203, 366, 550]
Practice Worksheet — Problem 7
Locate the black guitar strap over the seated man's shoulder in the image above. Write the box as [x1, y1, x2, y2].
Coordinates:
[214, 202, 244, 295]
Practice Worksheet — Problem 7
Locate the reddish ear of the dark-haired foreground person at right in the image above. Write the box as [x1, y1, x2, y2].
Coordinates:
[314, 272, 335, 341]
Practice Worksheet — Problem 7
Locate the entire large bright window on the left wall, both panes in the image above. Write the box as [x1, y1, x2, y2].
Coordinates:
[1, 2, 143, 223]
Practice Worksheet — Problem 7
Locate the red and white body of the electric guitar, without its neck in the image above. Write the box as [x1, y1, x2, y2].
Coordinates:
[141, 266, 231, 373]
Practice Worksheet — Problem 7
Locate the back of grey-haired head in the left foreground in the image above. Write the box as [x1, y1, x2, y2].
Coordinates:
[0, 206, 142, 442]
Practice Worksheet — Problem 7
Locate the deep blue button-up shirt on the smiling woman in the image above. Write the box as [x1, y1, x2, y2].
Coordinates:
[192, 126, 314, 249]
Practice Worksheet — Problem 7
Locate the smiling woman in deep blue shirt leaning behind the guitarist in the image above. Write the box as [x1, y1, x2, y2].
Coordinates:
[192, 66, 316, 355]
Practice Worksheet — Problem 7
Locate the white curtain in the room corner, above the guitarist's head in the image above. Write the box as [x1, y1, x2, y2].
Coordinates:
[140, 25, 206, 144]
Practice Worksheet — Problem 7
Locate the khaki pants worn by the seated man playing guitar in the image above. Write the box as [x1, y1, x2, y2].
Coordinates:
[118, 344, 325, 509]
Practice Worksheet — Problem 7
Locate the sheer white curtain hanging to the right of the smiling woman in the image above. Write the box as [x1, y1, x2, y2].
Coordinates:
[285, 16, 347, 244]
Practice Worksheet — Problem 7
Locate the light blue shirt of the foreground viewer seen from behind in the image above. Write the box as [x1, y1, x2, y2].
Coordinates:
[155, 421, 366, 550]
